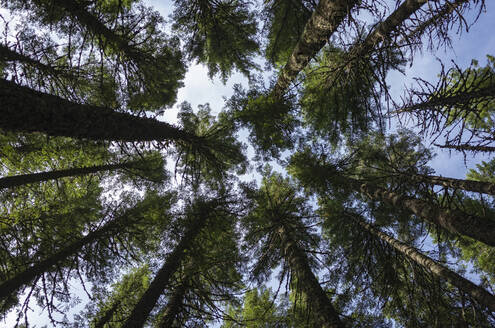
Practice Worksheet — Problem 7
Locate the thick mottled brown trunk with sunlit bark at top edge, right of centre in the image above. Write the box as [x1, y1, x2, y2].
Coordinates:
[272, 0, 359, 98]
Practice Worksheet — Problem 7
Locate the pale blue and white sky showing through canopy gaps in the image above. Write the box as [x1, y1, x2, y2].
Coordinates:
[5, 0, 495, 327]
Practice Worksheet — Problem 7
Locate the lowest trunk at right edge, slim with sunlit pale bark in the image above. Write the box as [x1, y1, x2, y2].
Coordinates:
[356, 218, 495, 312]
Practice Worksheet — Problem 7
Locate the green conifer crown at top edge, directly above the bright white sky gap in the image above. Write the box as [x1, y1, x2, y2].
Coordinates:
[172, 0, 259, 82]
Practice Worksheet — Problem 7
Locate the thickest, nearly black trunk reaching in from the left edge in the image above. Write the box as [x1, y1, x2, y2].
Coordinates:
[0, 79, 203, 143]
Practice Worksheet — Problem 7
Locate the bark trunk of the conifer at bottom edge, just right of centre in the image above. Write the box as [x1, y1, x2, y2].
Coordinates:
[278, 225, 344, 328]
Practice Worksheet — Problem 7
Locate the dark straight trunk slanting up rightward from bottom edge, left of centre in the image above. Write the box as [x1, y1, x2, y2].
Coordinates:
[122, 217, 206, 328]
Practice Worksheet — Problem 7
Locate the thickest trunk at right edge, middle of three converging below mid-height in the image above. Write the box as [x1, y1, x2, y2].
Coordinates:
[348, 178, 495, 246]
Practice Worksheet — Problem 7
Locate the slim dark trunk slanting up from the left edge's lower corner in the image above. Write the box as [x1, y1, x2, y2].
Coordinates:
[0, 220, 120, 300]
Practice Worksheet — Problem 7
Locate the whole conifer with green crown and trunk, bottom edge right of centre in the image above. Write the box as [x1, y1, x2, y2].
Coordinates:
[246, 172, 343, 327]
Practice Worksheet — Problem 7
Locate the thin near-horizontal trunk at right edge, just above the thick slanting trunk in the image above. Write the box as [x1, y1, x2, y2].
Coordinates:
[405, 174, 495, 196]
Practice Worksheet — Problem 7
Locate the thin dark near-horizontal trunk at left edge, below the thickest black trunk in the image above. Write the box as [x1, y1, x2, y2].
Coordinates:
[0, 161, 141, 189]
